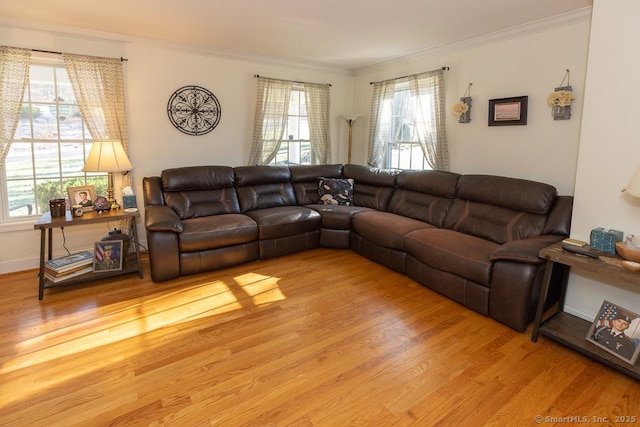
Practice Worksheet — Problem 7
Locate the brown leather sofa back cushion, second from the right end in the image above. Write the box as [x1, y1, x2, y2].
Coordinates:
[388, 171, 460, 227]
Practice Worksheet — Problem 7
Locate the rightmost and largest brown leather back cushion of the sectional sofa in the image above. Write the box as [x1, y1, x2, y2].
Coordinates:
[445, 175, 557, 244]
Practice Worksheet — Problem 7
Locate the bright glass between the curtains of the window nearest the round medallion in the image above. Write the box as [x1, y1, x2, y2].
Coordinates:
[269, 89, 314, 165]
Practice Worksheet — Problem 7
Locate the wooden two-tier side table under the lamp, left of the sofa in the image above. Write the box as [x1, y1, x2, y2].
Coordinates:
[33, 209, 143, 300]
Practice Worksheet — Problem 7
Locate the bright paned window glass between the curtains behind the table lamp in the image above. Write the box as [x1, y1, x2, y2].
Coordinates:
[0, 59, 107, 220]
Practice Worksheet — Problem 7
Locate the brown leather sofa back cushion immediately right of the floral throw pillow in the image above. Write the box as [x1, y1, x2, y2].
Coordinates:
[342, 164, 398, 211]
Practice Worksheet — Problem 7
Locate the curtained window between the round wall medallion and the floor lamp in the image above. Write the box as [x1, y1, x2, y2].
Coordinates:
[249, 77, 331, 165]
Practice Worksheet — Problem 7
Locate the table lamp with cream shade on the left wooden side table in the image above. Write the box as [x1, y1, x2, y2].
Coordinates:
[82, 141, 133, 209]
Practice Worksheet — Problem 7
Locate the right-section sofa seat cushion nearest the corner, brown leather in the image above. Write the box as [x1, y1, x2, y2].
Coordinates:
[352, 211, 435, 251]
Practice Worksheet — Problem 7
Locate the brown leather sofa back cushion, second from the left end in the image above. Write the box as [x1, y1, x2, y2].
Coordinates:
[234, 166, 297, 212]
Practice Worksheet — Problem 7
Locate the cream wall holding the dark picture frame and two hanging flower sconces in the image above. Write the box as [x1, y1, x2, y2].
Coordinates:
[353, 11, 589, 195]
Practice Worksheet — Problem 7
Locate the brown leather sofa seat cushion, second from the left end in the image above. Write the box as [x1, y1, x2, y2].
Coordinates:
[246, 206, 321, 240]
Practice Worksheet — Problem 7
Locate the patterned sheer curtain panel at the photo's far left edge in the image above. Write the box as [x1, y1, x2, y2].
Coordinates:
[0, 46, 31, 167]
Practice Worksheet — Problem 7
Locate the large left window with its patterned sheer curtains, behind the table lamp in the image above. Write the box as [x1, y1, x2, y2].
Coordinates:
[0, 47, 127, 221]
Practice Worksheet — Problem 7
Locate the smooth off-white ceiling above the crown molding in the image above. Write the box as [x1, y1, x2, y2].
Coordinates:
[0, 0, 593, 69]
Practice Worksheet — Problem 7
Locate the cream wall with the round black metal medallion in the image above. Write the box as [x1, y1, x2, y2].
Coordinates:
[0, 26, 353, 274]
